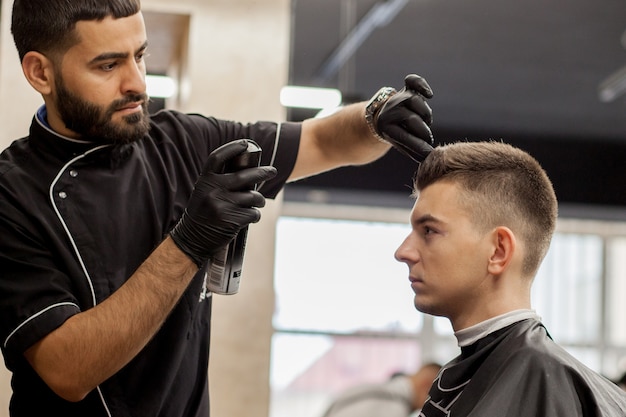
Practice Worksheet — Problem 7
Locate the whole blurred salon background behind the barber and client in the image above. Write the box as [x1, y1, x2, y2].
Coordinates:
[0, 0, 626, 417]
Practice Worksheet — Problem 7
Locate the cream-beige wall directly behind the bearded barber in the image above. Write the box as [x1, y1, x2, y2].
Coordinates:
[0, 0, 290, 417]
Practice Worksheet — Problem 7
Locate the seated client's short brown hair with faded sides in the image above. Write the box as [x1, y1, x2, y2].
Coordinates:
[415, 141, 557, 276]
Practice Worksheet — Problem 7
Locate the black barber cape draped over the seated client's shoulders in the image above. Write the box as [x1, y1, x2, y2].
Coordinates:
[419, 318, 626, 417]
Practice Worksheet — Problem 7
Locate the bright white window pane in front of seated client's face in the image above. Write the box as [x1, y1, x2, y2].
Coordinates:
[274, 217, 421, 333]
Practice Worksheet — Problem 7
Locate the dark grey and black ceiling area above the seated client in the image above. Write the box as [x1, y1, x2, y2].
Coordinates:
[287, 0, 626, 212]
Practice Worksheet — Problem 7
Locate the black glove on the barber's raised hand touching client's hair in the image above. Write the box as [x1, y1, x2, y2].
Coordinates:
[375, 74, 433, 162]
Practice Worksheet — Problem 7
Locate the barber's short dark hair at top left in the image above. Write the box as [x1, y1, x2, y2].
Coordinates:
[11, 0, 141, 61]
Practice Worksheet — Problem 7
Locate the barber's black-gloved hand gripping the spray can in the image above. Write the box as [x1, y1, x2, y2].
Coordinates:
[170, 139, 276, 267]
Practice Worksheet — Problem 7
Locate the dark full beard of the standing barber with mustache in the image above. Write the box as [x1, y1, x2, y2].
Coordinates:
[55, 78, 150, 145]
